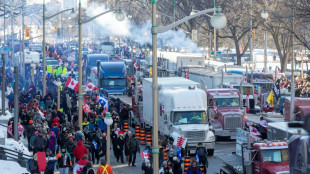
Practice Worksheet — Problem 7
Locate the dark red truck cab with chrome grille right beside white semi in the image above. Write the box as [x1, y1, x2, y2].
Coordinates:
[206, 89, 243, 139]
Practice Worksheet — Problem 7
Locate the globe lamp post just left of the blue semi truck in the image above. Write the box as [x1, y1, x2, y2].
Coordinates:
[78, 0, 125, 130]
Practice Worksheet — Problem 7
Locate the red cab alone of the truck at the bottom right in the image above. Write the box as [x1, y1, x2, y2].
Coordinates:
[251, 142, 290, 174]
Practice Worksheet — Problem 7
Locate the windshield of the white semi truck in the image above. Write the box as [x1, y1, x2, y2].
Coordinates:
[172, 111, 207, 125]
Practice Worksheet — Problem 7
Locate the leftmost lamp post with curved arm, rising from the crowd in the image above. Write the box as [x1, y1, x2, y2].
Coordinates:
[42, 0, 74, 97]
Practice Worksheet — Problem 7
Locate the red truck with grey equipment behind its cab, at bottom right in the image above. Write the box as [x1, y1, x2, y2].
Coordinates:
[216, 129, 290, 174]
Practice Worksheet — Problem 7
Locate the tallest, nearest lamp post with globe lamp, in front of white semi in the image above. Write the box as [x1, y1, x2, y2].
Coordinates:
[151, 0, 227, 173]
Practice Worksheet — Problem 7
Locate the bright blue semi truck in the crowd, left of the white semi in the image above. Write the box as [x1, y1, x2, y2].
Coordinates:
[97, 61, 127, 96]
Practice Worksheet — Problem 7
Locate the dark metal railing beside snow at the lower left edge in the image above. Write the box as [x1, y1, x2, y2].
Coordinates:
[0, 147, 32, 167]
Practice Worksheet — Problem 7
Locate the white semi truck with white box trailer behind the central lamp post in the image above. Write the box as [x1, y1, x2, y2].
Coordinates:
[142, 77, 215, 155]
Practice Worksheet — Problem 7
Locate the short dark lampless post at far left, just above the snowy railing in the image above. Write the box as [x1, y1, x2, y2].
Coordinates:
[14, 66, 19, 141]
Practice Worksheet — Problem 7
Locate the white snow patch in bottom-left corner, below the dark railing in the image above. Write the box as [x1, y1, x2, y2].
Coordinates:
[0, 160, 29, 174]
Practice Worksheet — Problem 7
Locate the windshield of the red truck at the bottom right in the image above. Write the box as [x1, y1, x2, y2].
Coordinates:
[262, 149, 288, 162]
